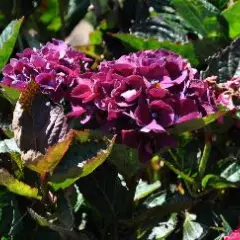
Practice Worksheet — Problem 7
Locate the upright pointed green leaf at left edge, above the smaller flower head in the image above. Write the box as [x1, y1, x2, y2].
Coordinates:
[0, 18, 23, 70]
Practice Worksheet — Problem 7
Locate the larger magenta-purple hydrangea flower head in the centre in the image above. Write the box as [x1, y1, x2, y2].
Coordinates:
[69, 50, 215, 160]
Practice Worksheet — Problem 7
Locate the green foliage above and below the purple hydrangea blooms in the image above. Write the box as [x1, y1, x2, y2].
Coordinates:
[0, 0, 240, 240]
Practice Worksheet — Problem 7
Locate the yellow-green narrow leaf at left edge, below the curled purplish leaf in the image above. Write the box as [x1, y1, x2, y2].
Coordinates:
[0, 168, 41, 200]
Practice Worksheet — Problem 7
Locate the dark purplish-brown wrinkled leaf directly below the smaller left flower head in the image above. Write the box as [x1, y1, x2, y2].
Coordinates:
[12, 81, 68, 163]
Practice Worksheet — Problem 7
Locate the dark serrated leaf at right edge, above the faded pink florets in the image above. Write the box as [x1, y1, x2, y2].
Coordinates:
[202, 38, 240, 83]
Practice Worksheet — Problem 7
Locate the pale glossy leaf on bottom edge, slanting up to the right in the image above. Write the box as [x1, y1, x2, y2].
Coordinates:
[147, 213, 177, 240]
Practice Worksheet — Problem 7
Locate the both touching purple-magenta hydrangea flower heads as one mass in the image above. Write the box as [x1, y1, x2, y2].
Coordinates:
[2, 43, 216, 161]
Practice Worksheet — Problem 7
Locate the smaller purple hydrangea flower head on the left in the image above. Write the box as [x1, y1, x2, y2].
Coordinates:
[1, 39, 90, 100]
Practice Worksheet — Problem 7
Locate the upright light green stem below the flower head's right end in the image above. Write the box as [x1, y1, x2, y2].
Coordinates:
[198, 129, 211, 179]
